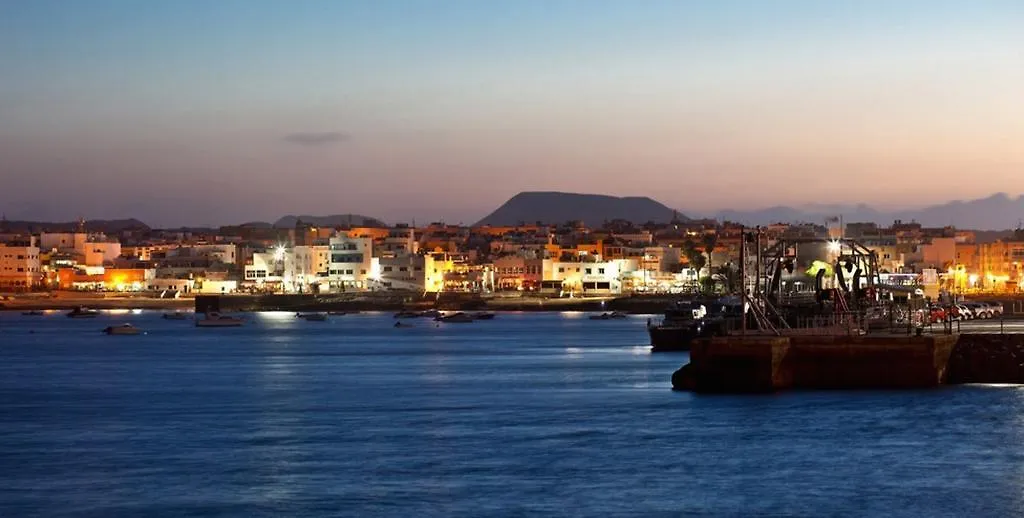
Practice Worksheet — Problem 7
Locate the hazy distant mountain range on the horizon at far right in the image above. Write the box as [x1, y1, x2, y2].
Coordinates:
[709, 192, 1024, 230]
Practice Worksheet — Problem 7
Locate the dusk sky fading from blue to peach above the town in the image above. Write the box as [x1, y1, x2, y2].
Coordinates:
[0, 0, 1024, 226]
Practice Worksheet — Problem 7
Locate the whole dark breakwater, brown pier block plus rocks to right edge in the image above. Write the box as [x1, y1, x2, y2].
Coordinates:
[672, 333, 1024, 393]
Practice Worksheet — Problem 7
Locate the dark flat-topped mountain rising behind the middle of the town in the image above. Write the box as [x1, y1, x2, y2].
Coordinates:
[476, 192, 687, 225]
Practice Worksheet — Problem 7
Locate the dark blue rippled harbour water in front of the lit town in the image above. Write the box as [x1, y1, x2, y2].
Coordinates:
[0, 313, 1024, 517]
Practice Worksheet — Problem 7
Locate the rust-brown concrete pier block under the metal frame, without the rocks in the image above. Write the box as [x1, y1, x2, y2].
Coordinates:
[672, 335, 957, 393]
